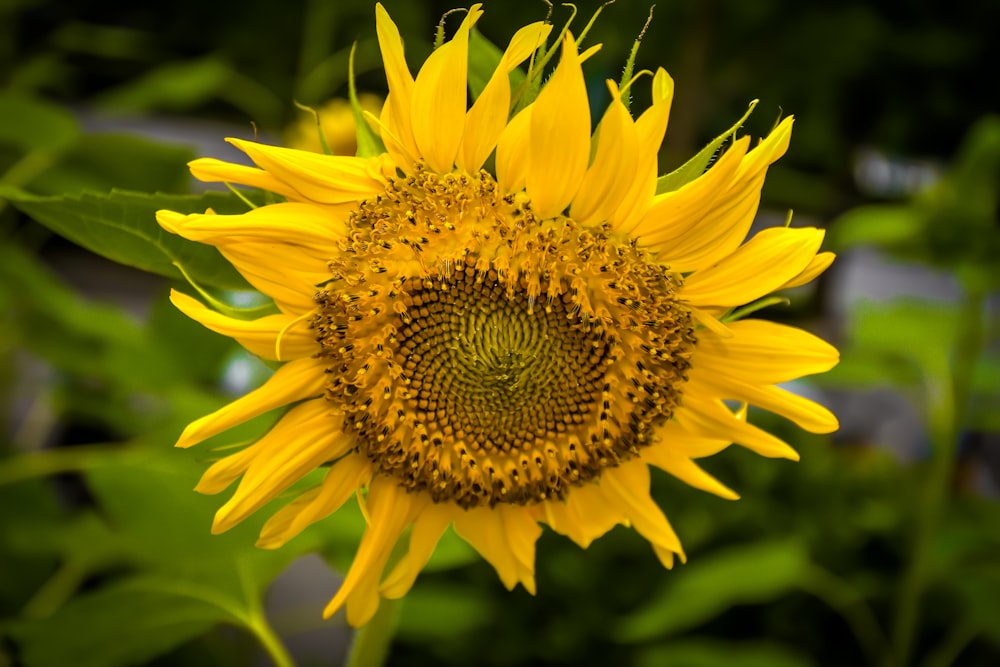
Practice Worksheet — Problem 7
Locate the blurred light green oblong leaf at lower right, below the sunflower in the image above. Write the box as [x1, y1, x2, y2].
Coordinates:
[616, 541, 809, 642]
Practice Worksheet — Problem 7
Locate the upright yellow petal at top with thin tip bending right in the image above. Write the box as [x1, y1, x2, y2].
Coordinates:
[410, 5, 483, 173]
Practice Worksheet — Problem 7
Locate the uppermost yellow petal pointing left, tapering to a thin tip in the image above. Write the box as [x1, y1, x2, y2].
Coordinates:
[227, 139, 385, 204]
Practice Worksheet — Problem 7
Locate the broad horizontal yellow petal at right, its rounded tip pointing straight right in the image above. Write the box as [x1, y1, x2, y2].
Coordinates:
[692, 320, 840, 384]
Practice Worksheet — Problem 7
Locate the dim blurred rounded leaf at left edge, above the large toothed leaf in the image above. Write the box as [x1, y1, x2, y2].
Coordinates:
[0, 93, 79, 153]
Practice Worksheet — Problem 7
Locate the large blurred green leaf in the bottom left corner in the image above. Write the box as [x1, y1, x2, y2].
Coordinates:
[12, 577, 232, 667]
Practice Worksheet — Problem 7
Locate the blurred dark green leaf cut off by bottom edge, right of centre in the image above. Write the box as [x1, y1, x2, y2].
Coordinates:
[635, 639, 816, 667]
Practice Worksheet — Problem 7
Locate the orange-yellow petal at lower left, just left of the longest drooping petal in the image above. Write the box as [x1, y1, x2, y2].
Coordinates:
[257, 454, 372, 549]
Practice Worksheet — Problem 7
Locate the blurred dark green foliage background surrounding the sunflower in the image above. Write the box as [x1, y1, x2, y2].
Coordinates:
[0, 0, 1000, 667]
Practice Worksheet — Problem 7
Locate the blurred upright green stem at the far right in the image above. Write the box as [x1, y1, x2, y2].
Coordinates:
[887, 291, 985, 667]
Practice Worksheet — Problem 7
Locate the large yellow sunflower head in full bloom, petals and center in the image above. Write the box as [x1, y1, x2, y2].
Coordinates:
[158, 5, 837, 626]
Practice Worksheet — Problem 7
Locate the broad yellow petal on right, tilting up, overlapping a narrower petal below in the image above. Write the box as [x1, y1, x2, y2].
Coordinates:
[680, 227, 824, 307]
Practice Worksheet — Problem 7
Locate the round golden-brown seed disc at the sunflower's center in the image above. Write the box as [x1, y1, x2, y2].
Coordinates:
[312, 166, 694, 507]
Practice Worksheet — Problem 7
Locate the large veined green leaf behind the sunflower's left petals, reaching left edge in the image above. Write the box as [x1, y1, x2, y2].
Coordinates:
[0, 186, 251, 290]
